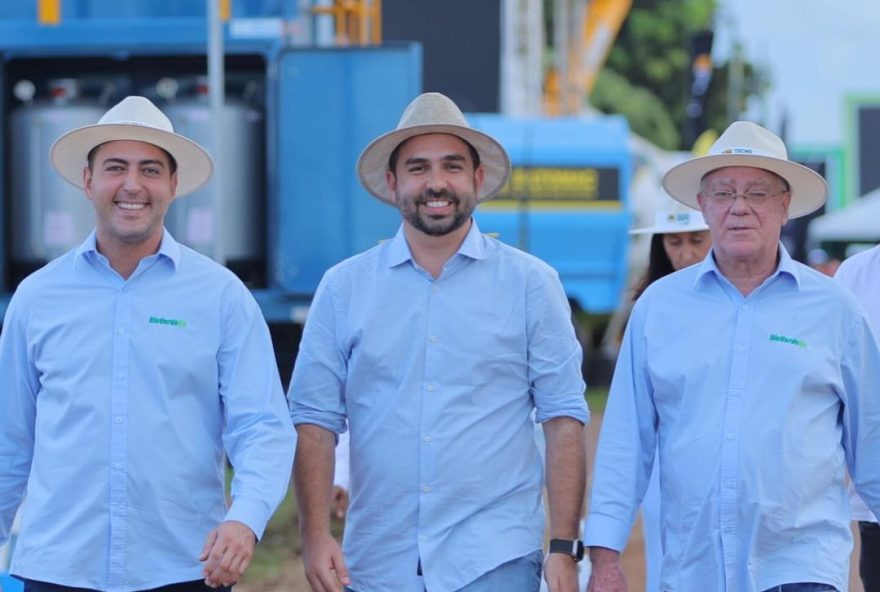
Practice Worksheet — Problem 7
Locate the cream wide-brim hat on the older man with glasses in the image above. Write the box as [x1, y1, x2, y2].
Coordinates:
[663, 121, 828, 218]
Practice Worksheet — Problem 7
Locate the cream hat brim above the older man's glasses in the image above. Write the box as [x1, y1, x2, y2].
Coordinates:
[663, 154, 828, 219]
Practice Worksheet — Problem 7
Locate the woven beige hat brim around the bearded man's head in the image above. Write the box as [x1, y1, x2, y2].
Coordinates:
[357, 124, 510, 205]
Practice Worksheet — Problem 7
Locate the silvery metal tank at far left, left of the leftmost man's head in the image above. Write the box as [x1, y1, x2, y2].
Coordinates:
[9, 79, 105, 284]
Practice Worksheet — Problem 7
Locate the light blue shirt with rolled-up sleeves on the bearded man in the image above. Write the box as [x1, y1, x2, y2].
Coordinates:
[290, 222, 588, 592]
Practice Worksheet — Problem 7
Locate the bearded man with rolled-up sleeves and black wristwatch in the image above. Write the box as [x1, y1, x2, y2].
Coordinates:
[289, 93, 588, 592]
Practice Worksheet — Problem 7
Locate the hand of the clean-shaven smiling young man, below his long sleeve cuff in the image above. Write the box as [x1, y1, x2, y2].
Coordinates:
[199, 520, 257, 588]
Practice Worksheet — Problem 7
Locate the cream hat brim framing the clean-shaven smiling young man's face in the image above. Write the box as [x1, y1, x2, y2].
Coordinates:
[49, 123, 214, 197]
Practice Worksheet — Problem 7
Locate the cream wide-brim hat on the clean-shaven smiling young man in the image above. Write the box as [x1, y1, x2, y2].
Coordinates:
[49, 96, 214, 196]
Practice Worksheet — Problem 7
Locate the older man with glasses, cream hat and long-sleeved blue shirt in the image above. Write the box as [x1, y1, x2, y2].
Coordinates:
[585, 122, 880, 592]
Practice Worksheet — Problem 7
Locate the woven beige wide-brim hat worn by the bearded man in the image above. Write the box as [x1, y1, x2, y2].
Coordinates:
[357, 92, 510, 205]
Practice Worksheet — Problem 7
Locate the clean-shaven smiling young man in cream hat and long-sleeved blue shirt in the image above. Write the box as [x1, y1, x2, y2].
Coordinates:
[0, 97, 294, 592]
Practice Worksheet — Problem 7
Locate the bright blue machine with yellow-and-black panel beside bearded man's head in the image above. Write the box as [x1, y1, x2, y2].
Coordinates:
[470, 115, 633, 314]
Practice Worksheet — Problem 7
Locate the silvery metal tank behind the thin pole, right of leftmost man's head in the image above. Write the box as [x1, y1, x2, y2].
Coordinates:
[163, 81, 266, 286]
